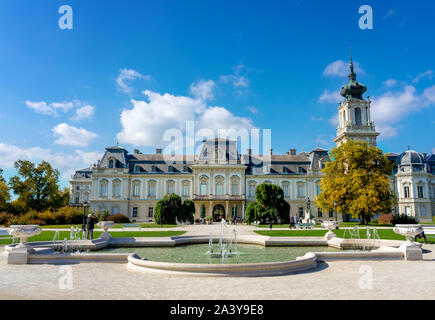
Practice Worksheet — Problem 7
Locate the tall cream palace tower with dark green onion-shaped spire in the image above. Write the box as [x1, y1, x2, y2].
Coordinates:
[334, 54, 379, 146]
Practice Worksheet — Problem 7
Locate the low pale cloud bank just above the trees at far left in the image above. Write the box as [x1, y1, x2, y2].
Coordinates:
[0, 142, 102, 178]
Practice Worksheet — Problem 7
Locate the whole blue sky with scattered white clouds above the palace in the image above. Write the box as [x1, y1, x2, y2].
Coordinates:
[0, 0, 435, 189]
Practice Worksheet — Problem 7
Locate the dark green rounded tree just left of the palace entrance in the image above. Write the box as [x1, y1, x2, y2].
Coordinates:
[154, 193, 183, 224]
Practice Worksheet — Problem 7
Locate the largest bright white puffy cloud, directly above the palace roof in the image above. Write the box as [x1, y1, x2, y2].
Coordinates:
[117, 90, 253, 146]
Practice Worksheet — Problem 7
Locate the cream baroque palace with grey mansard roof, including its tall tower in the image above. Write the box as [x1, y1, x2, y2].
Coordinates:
[70, 60, 435, 221]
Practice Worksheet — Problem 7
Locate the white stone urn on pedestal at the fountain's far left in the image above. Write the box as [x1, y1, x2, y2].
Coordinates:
[7, 225, 41, 264]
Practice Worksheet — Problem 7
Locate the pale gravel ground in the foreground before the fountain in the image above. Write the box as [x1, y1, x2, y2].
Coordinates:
[0, 245, 435, 300]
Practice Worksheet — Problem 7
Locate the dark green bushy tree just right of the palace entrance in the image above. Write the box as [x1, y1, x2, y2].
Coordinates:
[245, 183, 290, 223]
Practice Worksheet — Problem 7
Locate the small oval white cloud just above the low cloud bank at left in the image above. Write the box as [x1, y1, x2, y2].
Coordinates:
[52, 123, 97, 147]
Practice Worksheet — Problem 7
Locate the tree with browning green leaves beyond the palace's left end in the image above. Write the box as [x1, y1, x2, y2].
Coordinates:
[9, 160, 66, 212]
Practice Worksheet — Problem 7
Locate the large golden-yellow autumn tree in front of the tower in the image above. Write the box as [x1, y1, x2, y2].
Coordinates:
[316, 140, 396, 224]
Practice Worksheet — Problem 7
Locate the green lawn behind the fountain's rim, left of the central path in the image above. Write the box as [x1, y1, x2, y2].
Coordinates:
[0, 231, 186, 244]
